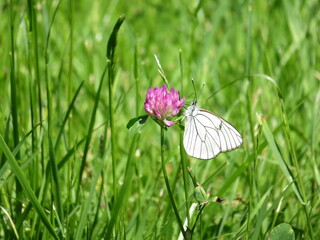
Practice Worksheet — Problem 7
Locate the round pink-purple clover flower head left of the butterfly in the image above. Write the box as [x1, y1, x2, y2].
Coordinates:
[144, 85, 186, 127]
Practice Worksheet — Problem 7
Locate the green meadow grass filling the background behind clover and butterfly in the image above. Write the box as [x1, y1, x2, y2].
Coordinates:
[0, 0, 320, 239]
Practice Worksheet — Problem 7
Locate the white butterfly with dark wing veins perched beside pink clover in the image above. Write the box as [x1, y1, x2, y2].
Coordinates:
[183, 101, 242, 159]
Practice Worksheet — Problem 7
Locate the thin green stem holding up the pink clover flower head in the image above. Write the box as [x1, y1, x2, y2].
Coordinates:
[161, 127, 186, 239]
